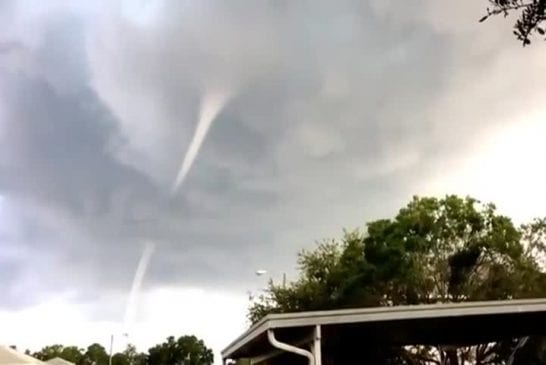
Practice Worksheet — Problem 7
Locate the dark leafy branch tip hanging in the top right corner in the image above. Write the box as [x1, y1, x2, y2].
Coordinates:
[480, 0, 546, 46]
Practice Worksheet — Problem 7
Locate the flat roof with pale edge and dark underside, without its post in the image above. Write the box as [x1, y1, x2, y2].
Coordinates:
[222, 298, 546, 359]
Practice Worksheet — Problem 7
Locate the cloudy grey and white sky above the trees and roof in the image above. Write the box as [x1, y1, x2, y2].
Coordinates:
[0, 0, 546, 360]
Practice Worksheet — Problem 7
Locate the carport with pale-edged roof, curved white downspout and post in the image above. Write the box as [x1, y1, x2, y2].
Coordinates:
[222, 298, 546, 365]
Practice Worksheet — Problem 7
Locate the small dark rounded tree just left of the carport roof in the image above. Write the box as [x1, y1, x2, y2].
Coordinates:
[148, 336, 214, 365]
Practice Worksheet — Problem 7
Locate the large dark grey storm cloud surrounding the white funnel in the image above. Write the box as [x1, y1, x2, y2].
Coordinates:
[2, 2, 450, 312]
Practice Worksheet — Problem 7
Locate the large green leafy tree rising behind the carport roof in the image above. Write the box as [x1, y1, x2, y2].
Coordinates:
[249, 196, 546, 364]
